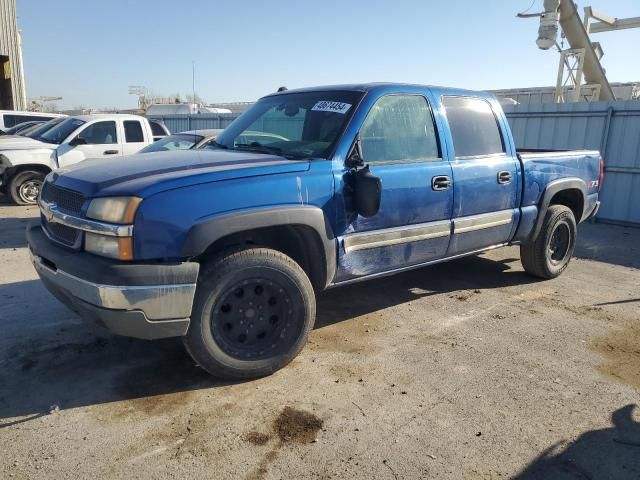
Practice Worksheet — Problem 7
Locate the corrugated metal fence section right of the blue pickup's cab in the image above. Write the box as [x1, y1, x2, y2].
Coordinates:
[505, 101, 640, 226]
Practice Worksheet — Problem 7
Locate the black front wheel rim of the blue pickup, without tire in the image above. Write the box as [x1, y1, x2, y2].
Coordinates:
[211, 278, 297, 360]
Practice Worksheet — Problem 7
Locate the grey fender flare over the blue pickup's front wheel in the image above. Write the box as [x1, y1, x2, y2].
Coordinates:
[183, 205, 337, 285]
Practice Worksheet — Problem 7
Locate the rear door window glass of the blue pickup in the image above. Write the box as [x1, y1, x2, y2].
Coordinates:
[443, 97, 505, 158]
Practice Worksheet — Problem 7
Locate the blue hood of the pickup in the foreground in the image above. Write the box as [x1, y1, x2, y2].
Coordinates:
[52, 150, 309, 198]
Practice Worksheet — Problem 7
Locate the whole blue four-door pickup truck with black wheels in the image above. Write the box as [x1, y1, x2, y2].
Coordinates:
[27, 84, 603, 378]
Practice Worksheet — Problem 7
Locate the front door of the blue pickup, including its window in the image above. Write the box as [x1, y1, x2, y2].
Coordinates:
[336, 94, 453, 281]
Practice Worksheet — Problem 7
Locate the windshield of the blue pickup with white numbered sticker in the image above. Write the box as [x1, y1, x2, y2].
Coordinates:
[211, 91, 363, 158]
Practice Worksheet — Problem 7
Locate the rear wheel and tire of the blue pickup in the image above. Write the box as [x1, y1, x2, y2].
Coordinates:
[520, 205, 577, 280]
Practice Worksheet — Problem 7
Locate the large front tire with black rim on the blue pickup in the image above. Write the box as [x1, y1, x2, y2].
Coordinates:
[183, 248, 316, 380]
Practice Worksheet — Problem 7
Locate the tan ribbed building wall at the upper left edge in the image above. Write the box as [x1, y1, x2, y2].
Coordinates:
[0, 0, 27, 110]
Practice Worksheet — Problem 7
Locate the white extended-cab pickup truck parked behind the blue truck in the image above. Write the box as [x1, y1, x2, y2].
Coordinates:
[0, 114, 169, 205]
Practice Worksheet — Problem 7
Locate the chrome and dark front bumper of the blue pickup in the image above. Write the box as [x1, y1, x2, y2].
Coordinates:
[27, 224, 199, 339]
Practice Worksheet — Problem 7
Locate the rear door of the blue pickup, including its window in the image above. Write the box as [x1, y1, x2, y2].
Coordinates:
[443, 96, 520, 256]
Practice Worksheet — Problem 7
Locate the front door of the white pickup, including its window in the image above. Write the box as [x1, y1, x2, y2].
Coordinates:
[58, 120, 122, 167]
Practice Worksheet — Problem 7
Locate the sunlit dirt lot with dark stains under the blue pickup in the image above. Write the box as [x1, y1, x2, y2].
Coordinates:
[0, 196, 640, 480]
